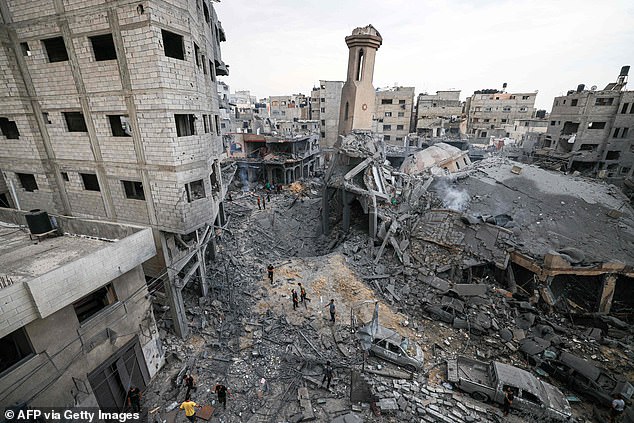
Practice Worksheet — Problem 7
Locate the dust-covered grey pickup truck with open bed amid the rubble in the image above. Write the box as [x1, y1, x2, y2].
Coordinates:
[447, 356, 572, 422]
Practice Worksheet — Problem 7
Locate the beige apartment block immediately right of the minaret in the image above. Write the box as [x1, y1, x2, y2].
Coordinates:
[374, 87, 415, 145]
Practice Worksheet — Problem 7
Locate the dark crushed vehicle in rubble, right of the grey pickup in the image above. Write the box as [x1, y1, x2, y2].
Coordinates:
[536, 351, 634, 407]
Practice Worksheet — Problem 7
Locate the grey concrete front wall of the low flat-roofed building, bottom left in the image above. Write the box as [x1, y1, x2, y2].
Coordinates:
[0, 266, 164, 407]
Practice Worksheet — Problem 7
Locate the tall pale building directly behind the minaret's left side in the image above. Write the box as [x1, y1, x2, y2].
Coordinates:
[310, 80, 343, 151]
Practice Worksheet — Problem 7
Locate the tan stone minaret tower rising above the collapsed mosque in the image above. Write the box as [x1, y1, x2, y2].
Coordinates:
[339, 25, 383, 134]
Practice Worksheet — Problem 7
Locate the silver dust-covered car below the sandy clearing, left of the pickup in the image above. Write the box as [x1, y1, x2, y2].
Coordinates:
[362, 326, 423, 372]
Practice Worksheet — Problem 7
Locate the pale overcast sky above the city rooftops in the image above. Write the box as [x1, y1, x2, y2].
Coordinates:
[214, 0, 634, 111]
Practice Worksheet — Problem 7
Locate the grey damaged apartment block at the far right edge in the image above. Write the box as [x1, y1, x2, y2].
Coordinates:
[537, 66, 634, 182]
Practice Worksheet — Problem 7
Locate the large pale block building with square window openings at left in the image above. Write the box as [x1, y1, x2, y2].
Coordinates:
[0, 0, 228, 336]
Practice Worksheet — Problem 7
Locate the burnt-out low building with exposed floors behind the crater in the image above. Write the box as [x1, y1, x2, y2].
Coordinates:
[228, 131, 319, 190]
